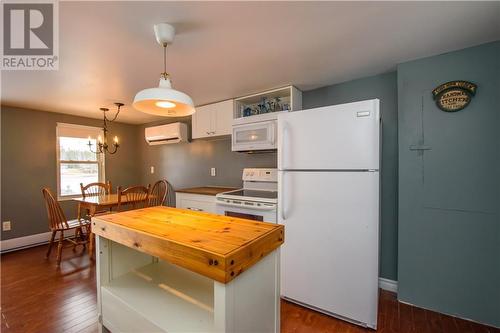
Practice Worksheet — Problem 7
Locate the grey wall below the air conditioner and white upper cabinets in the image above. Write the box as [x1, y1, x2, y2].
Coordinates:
[138, 119, 277, 188]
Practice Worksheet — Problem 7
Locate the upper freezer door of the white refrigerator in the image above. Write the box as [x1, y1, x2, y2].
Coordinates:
[278, 99, 380, 170]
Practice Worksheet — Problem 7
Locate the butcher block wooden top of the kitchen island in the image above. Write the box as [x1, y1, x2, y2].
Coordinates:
[92, 206, 284, 283]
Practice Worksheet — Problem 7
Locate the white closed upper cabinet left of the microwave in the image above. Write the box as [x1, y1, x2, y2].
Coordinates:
[192, 99, 234, 139]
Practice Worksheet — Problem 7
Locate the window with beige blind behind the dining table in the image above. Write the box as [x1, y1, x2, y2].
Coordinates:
[56, 123, 105, 199]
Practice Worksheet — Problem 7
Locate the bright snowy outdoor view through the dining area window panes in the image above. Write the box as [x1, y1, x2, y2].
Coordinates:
[59, 137, 100, 196]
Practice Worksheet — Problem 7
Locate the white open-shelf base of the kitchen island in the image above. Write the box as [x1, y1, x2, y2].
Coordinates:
[96, 236, 280, 333]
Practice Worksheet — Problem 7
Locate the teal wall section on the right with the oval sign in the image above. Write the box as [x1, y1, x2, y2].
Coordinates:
[397, 41, 500, 327]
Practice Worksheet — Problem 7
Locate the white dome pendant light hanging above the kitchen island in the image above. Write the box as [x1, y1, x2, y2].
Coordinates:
[132, 23, 195, 117]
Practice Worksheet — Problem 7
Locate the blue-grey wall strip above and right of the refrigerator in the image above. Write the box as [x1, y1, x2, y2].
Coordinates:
[302, 72, 398, 280]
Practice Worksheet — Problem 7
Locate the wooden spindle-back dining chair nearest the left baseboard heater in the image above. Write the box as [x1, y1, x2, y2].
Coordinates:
[42, 188, 90, 266]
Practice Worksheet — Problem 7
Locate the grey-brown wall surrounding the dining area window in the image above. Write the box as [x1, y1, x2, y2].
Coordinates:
[1, 106, 140, 239]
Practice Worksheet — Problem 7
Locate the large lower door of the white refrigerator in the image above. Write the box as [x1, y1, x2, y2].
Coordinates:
[278, 171, 379, 328]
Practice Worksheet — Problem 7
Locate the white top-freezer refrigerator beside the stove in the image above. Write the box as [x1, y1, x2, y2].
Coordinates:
[278, 99, 381, 329]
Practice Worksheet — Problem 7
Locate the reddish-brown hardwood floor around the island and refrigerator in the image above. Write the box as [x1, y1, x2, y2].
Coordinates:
[1, 246, 500, 333]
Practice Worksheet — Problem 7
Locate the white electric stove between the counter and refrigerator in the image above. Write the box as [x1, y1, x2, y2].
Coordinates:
[215, 168, 278, 223]
